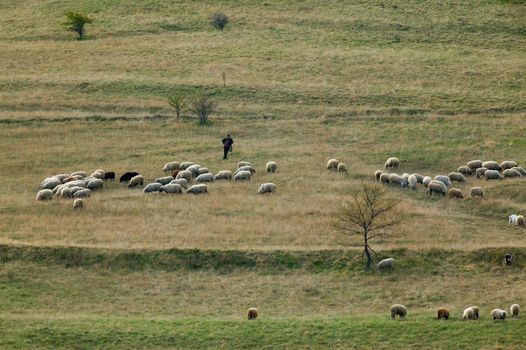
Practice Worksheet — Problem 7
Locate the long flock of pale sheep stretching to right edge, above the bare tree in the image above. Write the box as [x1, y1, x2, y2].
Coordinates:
[374, 157, 526, 199]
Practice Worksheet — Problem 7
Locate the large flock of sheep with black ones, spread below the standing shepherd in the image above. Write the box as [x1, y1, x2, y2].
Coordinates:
[36, 161, 278, 209]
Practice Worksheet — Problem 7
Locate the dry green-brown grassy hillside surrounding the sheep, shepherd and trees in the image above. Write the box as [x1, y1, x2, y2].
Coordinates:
[0, 0, 526, 349]
